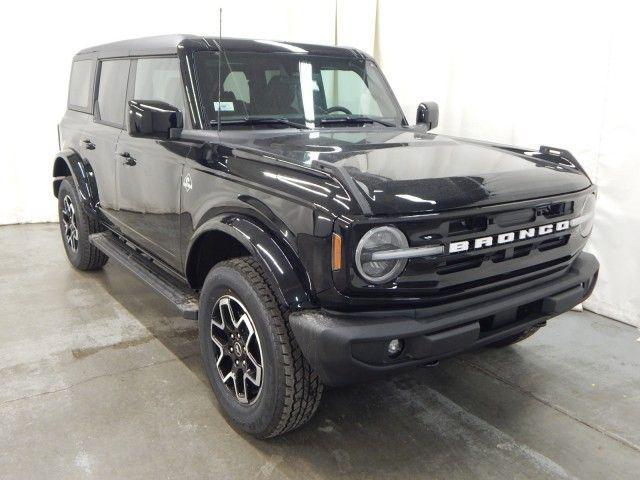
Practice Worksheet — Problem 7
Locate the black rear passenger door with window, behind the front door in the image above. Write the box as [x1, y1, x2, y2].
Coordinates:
[80, 59, 130, 220]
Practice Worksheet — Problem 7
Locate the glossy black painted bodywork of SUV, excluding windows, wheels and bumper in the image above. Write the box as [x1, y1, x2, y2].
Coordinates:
[54, 36, 594, 310]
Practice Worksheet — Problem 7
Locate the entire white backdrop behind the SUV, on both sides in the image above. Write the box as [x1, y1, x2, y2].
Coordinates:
[0, 0, 640, 326]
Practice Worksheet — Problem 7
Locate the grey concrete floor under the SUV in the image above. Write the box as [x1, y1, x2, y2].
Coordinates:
[0, 225, 640, 480]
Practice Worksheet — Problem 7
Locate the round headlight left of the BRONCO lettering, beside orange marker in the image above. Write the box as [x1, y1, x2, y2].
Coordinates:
[356, 227, 409, 284]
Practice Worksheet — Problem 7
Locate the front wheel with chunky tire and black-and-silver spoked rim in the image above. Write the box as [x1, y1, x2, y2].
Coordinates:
[198, 257, 323, 438]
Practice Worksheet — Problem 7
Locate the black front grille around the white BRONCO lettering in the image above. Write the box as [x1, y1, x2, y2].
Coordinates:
[348, 189, 585, 303]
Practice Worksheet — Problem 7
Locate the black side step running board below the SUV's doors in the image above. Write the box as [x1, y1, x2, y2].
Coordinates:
[89, 232, 198, 320]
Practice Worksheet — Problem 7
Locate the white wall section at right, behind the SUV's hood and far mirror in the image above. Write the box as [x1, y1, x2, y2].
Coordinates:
[374, 0, 640, 326]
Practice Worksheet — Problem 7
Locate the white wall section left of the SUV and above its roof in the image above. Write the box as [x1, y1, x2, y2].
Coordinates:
[0, 0, 335, 225]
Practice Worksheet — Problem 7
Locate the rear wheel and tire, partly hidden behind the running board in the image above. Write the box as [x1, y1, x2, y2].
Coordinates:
[58, 177, 109, 271]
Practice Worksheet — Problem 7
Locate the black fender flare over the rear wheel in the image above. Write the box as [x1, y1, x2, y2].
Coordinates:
[53, 148, 98, 216]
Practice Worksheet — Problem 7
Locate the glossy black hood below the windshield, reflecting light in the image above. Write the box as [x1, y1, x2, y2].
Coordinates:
[210, 127, 591, 215]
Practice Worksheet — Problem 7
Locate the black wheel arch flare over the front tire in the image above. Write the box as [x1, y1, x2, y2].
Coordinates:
[185, 213, 313, 310]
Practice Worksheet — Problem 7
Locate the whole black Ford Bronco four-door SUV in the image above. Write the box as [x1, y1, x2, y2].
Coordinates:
[53, 35, 599, 437]
